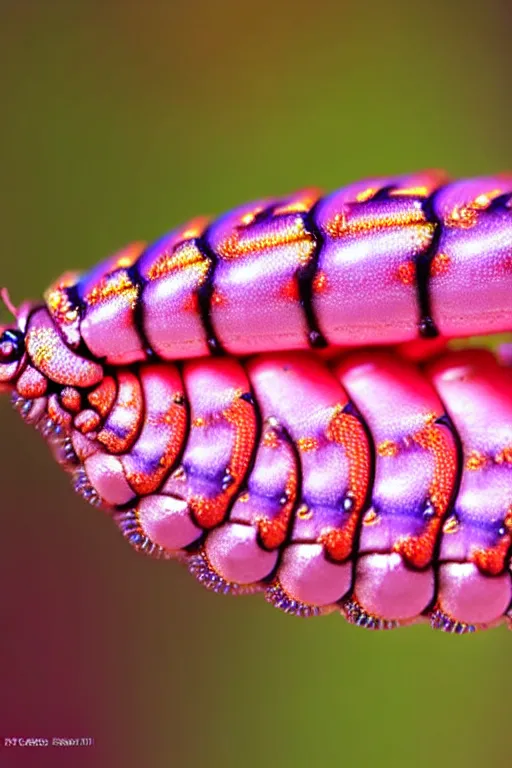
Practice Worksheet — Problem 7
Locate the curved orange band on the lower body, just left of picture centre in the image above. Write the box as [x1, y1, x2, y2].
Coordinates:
[189, 397, 256, 529]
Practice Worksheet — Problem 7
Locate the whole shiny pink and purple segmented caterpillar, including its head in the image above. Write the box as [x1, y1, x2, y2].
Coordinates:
[0, 172, 512, 634]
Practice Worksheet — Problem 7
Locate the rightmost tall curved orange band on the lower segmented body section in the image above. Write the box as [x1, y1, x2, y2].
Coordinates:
[393, 414, 457, 568]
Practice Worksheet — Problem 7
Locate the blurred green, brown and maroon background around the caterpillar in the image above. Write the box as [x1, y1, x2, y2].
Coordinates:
[0, 0, 512, 768]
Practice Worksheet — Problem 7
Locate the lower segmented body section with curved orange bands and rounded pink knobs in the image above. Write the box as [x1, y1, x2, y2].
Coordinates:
[23, 351, 512, 632]
